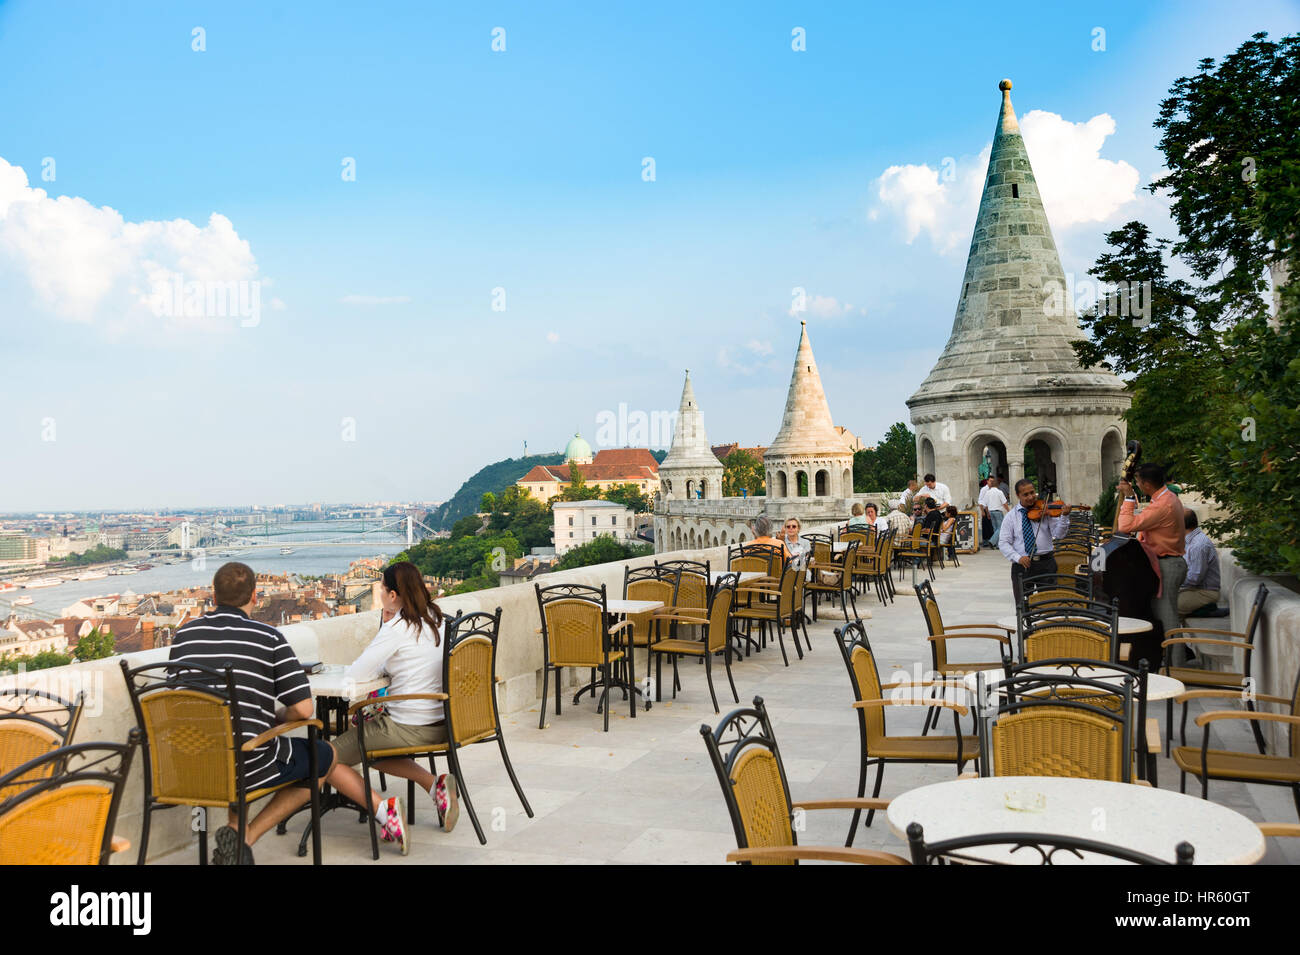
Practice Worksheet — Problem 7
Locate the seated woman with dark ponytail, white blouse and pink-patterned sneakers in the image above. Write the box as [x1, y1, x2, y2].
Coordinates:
[330, 560, 460, 855]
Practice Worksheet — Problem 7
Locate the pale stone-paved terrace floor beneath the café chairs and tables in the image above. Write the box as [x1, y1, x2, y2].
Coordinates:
[156, 552, 1300, 865]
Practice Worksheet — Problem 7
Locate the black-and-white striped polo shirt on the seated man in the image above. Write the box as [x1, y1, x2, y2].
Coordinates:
[169, 607, 312, 790]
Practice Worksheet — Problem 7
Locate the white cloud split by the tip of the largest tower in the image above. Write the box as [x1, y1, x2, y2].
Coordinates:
[867, 109, 1139, 253]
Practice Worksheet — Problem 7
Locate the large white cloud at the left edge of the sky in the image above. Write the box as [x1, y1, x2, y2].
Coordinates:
[0, 159, 265, 324]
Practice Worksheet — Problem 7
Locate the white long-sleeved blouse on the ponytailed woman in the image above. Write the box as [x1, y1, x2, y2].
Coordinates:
[347, 613, 446, 726]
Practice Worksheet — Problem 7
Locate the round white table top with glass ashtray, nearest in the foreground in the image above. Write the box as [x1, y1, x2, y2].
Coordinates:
[888, 776, 1265, 865]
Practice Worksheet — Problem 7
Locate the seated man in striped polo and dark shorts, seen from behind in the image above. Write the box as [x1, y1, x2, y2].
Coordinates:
[168, 563, 406, 865]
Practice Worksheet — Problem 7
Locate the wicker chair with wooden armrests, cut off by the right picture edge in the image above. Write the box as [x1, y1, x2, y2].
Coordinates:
[1173, 673, 1300, 815]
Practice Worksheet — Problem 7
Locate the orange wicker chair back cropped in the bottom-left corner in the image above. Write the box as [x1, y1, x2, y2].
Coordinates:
[0, 729, 140, 865]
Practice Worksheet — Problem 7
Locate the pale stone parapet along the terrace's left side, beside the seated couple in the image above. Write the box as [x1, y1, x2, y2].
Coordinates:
[0, 530, 826, 863]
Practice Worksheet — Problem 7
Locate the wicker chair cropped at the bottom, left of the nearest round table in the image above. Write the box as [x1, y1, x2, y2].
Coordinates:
[699, 696, 907, 865]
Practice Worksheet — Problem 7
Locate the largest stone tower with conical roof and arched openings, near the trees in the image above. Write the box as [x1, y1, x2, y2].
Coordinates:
[907, 79, 1130, 507]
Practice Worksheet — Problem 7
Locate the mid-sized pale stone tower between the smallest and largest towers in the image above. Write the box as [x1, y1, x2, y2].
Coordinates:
[763, 322, 853, 500]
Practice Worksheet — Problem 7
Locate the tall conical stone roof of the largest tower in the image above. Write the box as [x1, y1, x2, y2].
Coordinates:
[907, 79, 1123, 408]
